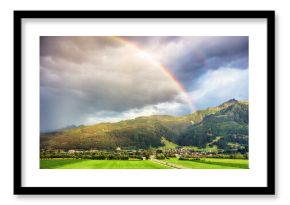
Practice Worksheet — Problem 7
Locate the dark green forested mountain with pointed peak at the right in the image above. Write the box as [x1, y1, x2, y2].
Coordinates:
[177, 101, 249, 152]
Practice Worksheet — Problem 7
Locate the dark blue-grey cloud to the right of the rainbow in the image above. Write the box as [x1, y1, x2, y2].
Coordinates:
[125, 36, 249, 89]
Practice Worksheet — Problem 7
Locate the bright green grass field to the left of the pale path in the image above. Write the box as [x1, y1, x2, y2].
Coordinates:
[40, 159, 169, 169]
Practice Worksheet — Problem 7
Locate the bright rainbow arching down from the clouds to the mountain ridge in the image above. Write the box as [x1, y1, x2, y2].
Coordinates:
[111, 36, 195, 111]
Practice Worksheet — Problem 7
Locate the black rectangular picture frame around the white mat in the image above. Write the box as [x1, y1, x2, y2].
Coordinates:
[14, 11, 275, 195]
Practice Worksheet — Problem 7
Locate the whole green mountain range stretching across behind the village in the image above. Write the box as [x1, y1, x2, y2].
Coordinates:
[40, 99, 248, 150]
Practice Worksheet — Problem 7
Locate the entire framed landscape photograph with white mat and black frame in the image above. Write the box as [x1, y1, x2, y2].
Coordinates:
[14, 11, 275, 195]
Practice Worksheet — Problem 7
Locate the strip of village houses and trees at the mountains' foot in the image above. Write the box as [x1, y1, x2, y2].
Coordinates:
[40, 147, 248, 160]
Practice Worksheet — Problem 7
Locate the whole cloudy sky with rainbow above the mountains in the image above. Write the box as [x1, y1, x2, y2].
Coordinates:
[40, 36, 249, 131]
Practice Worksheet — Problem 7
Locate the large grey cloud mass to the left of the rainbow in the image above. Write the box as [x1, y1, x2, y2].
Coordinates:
[40, 37, 184, 129]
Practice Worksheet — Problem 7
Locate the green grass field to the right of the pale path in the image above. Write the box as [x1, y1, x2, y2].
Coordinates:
[165, 158, 249, 169]
